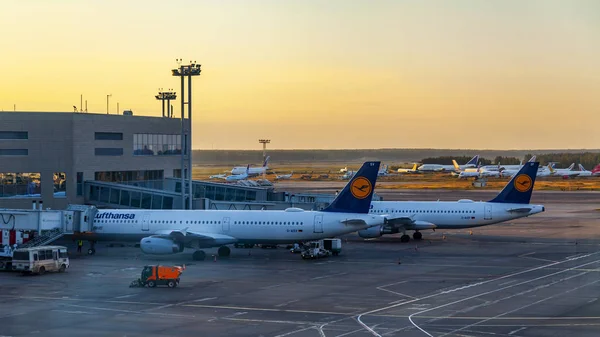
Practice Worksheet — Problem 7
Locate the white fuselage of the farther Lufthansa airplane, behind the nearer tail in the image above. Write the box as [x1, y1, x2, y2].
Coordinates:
[370, 200, 545, 229]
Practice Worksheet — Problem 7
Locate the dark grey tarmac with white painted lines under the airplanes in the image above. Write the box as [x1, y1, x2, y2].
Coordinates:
[0, 191, 600, 337]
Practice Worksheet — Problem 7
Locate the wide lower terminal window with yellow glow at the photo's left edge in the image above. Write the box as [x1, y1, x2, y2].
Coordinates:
[0, 172, 42, 198]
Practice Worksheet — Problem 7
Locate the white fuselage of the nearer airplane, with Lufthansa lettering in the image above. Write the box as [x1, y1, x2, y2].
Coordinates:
[86, 208, 383, 246]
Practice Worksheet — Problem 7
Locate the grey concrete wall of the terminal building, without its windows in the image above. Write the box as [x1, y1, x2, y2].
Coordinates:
[0, 112, 181, 209]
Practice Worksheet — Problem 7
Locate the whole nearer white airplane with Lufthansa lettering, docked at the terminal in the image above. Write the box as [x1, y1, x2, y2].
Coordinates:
[82, 161, 384, 260]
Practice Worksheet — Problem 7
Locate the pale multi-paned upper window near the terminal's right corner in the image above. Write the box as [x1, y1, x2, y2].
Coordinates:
[133, 133, 181, 156]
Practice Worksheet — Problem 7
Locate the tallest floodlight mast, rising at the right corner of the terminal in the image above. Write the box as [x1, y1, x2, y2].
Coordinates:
[171, 59, 202, 209]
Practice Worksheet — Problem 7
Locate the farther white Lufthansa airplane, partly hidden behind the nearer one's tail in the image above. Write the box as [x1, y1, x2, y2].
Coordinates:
[358, 162, 545, 242]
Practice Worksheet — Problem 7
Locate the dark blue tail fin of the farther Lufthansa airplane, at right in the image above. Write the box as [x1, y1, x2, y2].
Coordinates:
[490, 162, 540, 204]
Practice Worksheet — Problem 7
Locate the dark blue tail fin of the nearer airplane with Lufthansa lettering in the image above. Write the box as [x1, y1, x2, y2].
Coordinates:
[323, 161, 381, 213]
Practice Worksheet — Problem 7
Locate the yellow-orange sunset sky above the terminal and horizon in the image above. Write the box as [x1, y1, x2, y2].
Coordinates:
[0, 0, 600, 149]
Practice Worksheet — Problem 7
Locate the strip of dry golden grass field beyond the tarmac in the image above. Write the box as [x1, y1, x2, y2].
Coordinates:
[192, 163, 600, 191]
